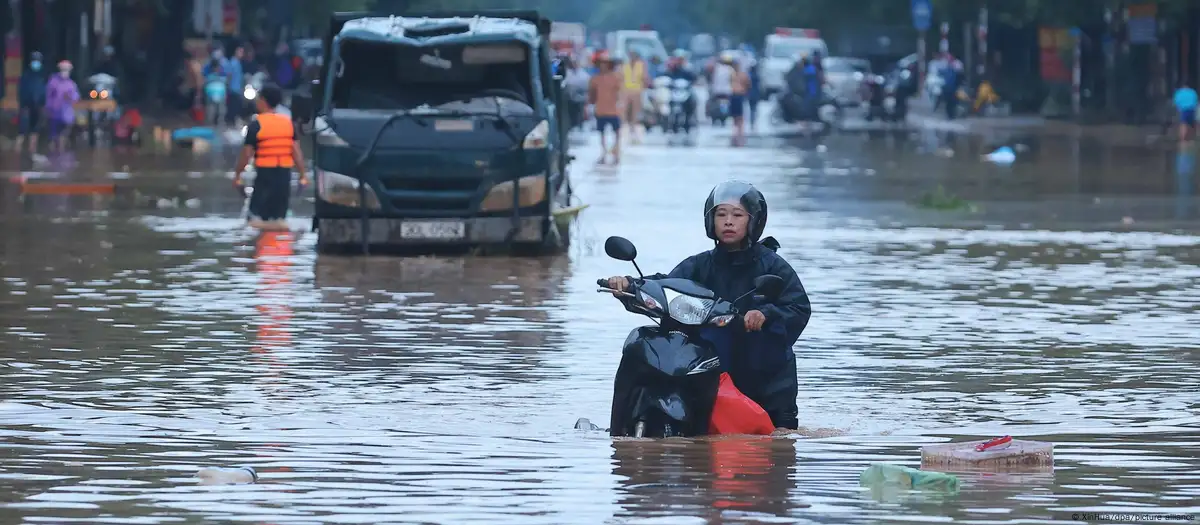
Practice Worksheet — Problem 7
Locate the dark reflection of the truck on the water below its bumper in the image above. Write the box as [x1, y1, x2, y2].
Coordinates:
[314, 257, 570, 381]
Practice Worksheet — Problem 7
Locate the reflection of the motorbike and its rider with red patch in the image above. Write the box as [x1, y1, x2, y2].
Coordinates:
[612, 436, 808, 523]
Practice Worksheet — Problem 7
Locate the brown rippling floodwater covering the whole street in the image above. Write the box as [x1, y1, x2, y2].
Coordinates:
[0, 124, 1200, 524]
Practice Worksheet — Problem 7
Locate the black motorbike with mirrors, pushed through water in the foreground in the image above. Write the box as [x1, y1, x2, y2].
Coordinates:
[596, 237, 784, 438]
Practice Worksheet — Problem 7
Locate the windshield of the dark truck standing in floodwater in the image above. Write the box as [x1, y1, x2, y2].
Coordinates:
[332, 41, 533, 114]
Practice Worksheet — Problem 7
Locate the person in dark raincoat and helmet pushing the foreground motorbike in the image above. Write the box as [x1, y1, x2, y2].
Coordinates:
[608, 181, 812, 429]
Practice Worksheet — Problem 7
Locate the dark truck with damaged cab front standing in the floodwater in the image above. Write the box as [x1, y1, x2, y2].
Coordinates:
[293, 11, 572, 253]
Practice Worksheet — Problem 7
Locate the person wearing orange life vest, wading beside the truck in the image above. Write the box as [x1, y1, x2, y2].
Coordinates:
[233, 84, 308, 229]
